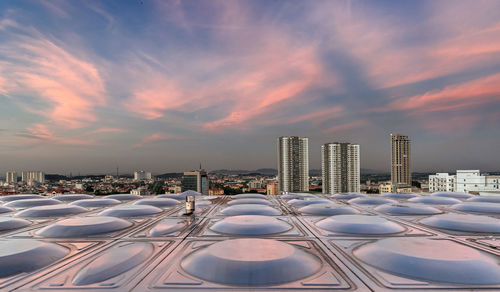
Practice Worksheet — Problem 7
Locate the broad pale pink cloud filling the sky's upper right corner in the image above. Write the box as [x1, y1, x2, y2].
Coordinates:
[310, 1, 500, 88]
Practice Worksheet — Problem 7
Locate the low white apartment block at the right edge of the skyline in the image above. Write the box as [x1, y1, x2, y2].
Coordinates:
[429, 170, 500, 193]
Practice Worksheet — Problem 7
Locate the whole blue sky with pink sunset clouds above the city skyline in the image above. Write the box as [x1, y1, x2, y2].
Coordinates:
[0, 0, 500, 175]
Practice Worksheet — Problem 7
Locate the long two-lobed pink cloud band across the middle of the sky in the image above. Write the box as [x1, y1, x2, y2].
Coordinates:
[124, 41, 324, 130]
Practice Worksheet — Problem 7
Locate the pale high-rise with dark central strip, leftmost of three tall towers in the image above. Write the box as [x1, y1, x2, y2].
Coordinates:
[278, 136, 309, 192]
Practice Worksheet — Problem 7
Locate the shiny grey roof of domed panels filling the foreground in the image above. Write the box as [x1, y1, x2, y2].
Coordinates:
[0, 194, 500, 292]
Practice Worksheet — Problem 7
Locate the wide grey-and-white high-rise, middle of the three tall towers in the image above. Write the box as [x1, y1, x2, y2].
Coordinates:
[321, 142, 360, 194]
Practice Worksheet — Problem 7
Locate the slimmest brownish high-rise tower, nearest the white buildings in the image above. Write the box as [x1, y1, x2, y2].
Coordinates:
[391, 134, 411, 187]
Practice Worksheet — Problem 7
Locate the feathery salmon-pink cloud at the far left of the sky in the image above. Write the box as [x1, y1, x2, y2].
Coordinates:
[1, 36, 107, 129]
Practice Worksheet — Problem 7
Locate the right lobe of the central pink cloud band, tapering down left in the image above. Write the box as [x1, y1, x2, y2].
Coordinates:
[203, 47, 326, 131]
